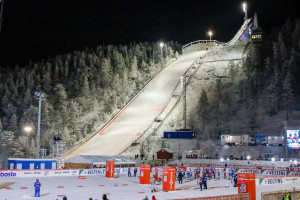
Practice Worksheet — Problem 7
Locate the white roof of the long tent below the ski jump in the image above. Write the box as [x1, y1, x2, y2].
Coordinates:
[65, 155, 136, 165]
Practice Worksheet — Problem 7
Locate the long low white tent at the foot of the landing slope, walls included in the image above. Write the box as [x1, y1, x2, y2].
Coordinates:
[64, 155, 136, 169]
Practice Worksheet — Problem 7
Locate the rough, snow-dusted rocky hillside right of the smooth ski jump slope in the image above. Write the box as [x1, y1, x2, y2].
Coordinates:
[136, 45, 247, 157]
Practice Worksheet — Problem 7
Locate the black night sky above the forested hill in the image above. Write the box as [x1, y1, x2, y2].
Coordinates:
[0, 0, 300, 67]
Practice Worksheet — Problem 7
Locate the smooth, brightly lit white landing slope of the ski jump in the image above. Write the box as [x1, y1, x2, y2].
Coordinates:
[65, 51, 207, 159]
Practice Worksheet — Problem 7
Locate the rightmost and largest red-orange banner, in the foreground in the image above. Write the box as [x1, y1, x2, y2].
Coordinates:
[238, 173, 256, 200]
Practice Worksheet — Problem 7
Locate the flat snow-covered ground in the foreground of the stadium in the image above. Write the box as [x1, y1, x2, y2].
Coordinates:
[0, 175, 300, 200]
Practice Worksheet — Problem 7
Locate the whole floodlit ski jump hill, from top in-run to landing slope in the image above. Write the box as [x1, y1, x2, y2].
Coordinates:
[63, 19, 251, 160]
